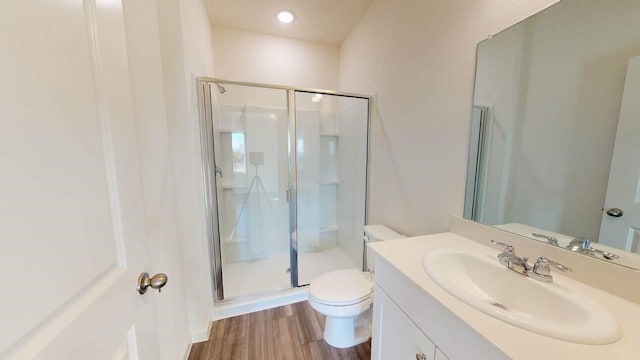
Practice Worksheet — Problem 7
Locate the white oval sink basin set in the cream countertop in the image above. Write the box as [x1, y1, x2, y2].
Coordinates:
[422, 249, 622, 345]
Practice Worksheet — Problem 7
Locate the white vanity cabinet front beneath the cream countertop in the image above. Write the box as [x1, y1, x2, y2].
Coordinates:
[369, 250, 509, 360]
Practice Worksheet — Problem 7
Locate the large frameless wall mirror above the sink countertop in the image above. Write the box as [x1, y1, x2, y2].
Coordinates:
[465, 0, 640, 269]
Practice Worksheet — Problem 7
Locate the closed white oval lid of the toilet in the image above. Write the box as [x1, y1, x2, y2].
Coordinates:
[309, 269, 373, 305]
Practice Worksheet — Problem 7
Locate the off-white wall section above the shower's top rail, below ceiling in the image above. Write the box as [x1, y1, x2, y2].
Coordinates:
[213, 27, 338, 90]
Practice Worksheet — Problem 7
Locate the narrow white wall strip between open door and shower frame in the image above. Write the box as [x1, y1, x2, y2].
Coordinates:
[158, 0, 218, 340]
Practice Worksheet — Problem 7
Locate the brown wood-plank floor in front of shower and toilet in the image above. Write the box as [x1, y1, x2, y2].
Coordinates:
[189, 301, 371, 360]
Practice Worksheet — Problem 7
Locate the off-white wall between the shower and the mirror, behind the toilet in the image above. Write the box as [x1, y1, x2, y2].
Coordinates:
[340, 0, 556, 235]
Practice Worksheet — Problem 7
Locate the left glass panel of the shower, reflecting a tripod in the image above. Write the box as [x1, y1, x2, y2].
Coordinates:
[209, 83, 291, 299]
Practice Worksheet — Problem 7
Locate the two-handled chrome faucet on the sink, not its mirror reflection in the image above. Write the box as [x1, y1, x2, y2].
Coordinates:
[491, 240, 571, 283]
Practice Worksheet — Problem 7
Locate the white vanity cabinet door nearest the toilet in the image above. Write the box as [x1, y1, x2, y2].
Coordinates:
[371, 286, 436, 360]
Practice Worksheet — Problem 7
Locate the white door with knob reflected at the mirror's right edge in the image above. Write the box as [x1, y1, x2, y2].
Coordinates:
[598, 56, 640, 252]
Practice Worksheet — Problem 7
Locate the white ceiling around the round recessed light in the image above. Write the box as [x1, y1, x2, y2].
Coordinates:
[203, 0, 373, 46]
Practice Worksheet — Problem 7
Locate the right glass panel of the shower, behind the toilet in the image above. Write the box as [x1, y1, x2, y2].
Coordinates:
[295, 91, 369, 285]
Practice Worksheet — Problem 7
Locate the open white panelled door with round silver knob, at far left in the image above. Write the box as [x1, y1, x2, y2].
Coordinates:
[0, 0, 158, 359]
